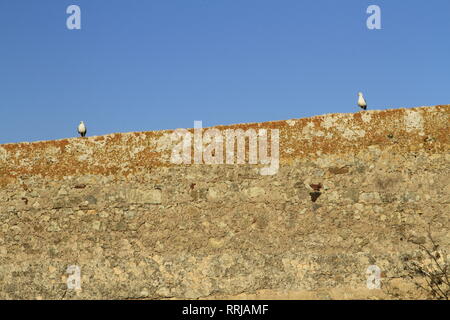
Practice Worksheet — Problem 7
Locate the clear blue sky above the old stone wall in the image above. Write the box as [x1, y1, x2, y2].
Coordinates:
[0, 0, 450, 143]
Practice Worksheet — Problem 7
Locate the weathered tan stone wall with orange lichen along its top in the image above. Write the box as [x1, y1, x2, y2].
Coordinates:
[0, 105, 450, 299]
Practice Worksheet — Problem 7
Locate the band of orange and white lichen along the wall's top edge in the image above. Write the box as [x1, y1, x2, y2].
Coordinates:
[0, 105, 450, 186]
